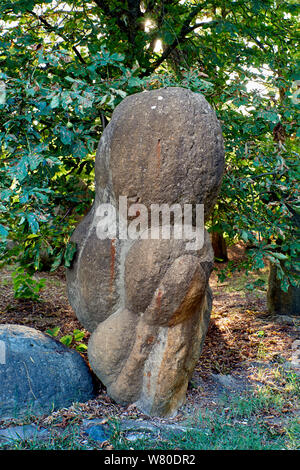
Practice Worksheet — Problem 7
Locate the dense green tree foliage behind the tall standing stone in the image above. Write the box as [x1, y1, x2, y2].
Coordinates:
[0, 0, 300, 298]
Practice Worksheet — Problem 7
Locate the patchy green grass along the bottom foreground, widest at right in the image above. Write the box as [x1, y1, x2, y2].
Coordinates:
[0, 367, 300, 450]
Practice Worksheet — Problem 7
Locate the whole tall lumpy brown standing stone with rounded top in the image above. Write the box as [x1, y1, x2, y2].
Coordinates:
[67, 87, 224, 416]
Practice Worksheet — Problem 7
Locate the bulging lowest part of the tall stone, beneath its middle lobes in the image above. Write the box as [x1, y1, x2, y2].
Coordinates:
[88, 286, 211, 417]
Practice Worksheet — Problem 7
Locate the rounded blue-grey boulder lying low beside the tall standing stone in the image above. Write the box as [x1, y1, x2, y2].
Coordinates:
[0, 324, 93, 419]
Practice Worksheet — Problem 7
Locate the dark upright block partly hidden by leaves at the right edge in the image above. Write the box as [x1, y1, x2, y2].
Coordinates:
[267, 264, 300, 315]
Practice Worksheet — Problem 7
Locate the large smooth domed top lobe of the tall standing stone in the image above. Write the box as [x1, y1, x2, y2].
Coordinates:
[95, 87, 224, 216]
